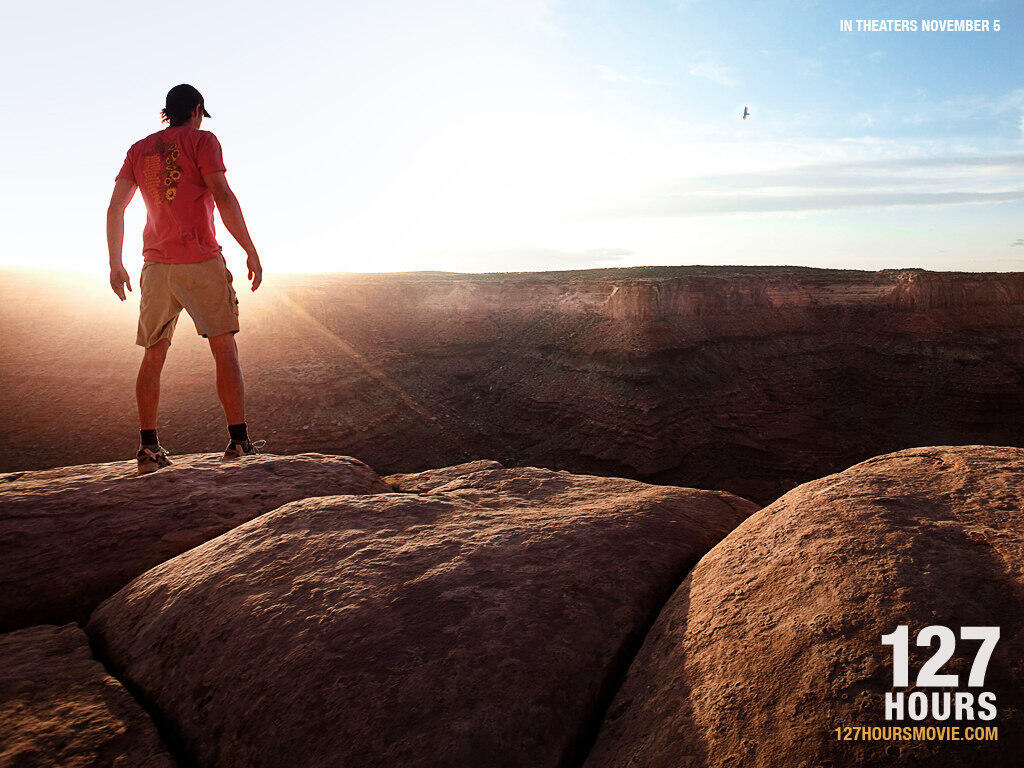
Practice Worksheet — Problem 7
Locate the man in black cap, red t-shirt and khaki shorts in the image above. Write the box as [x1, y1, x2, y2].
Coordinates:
[106, 85, 263, 474]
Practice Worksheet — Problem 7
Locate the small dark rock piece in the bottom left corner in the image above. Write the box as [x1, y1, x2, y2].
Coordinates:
[0, 625, 174, 768]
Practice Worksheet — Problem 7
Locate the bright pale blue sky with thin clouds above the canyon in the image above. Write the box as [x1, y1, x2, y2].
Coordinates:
[0, 0, 1024, 275]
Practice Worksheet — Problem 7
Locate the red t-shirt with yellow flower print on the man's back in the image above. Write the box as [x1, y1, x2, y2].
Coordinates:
[117, 125, 225, 264]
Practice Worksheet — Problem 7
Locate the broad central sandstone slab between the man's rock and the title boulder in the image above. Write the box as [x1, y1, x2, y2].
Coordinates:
[87, 468, 756, 768]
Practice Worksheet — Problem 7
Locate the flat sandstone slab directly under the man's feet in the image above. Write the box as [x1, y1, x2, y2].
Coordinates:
[0, 454, 391, 631]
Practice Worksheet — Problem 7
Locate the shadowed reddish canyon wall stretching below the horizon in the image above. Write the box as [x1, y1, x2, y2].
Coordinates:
[0, 267, 1024, 503]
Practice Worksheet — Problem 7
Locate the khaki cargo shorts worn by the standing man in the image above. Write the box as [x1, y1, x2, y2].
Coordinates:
[135, 256, 239, 347]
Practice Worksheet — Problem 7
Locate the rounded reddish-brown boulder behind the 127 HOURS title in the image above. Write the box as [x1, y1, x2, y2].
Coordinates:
[587, 446, 1024, 768]
